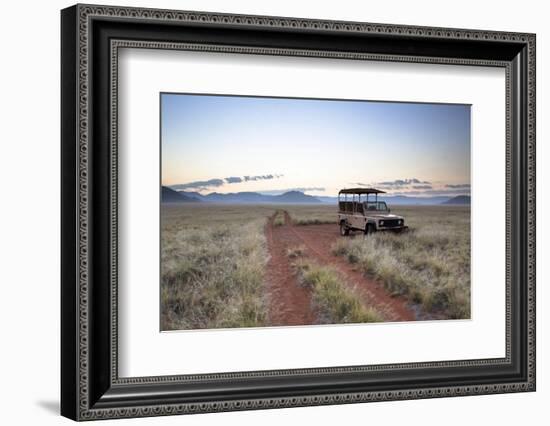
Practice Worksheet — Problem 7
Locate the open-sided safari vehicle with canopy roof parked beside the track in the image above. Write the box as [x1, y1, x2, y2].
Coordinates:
[338, 188, 408, 236]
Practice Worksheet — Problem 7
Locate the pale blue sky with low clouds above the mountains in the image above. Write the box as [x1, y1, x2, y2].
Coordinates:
[161, 93, 470, 196]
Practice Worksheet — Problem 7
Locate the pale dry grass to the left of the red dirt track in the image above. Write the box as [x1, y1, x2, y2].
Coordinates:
[161, 204, 274, 330]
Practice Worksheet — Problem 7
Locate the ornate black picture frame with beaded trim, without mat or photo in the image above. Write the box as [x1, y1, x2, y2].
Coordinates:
[61, 5, 536, 420]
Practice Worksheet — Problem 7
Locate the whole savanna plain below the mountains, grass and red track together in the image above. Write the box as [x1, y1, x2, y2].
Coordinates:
[160, 203, 471, 331]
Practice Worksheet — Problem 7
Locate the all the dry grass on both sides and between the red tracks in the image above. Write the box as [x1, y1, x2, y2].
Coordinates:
[160, 203, 470, 330]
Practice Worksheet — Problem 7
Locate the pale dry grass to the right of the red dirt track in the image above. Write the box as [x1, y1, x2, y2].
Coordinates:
[332, 206, 470, 318]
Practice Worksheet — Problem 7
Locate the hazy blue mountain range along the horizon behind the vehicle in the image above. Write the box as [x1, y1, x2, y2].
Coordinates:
[162, 186, 470, 206]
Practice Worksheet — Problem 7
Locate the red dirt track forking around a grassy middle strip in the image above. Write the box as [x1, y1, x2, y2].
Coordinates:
[266, 212, 417, 325]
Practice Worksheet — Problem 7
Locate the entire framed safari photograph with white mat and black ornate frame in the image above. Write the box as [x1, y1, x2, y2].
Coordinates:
[61, 5, 535, 420]
